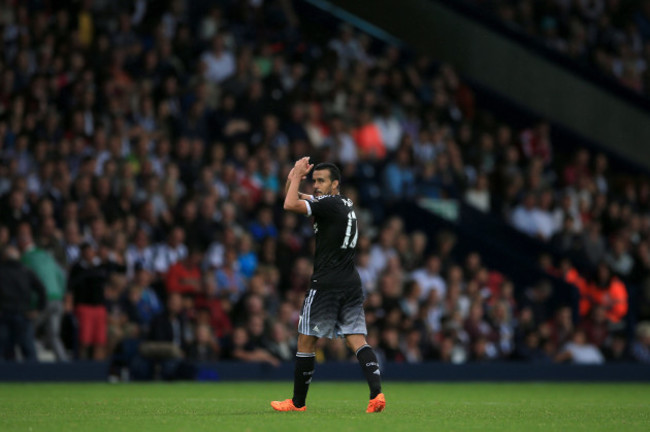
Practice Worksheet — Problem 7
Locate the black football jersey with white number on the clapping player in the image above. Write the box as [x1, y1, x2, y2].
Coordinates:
[308, 195, 361, 288]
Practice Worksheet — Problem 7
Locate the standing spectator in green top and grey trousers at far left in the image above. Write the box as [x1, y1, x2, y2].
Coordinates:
[18, 224, 68, 361]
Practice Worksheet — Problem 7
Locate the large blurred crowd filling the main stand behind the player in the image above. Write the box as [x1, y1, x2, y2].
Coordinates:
[0, 0, 650, 378]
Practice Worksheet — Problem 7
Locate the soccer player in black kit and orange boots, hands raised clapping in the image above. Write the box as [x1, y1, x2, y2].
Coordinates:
[271, 157, 386, 413]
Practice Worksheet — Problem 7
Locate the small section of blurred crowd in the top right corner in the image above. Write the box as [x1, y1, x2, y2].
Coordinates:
[472, 0, 650, 95]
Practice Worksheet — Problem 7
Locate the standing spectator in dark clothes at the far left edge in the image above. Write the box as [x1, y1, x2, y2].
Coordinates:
[0, 246, 45, 361]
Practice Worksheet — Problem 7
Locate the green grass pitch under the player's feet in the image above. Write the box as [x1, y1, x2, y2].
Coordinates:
[0, 381, 650, 432]
